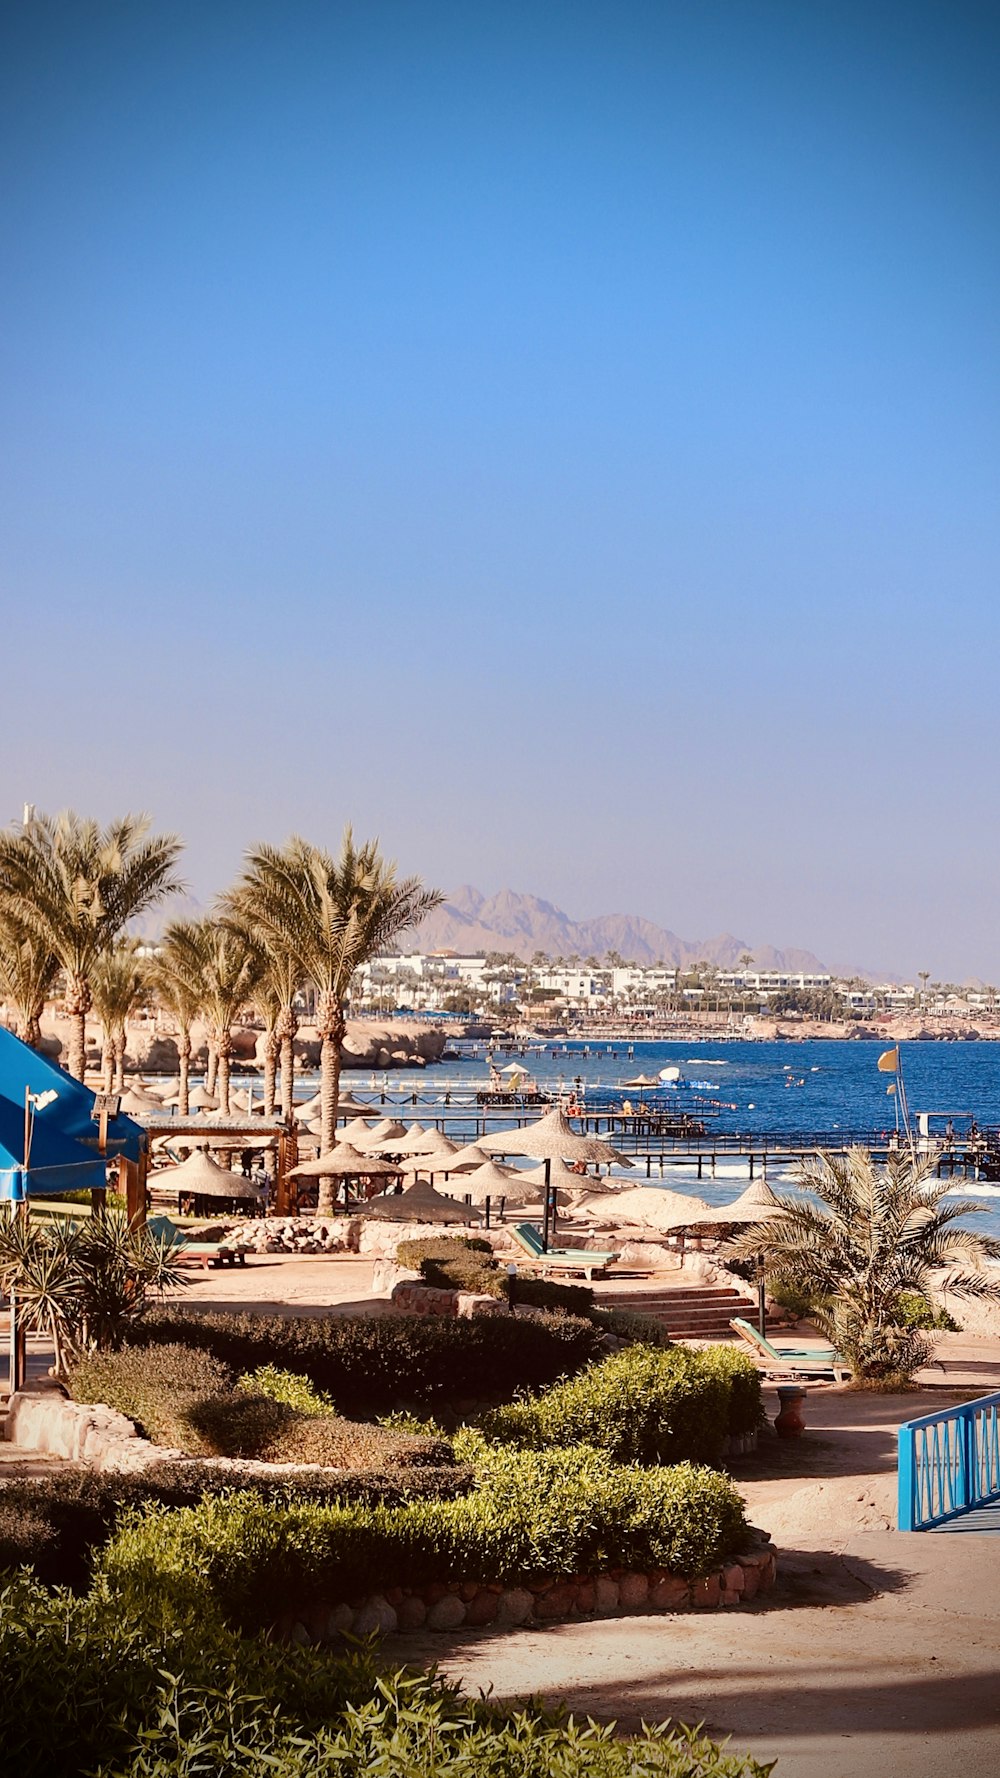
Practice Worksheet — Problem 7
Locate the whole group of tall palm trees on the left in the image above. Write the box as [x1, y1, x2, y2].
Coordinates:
[0, 811, 441, 1202]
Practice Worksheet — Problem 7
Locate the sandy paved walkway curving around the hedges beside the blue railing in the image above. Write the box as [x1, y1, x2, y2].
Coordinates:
[390, 1335, 1000, 1778]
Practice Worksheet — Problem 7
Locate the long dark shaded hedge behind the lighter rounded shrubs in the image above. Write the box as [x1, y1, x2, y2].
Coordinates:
[135, 1310, 601, 1419]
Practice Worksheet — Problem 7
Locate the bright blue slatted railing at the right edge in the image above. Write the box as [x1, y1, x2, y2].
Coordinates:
[899, 1396, 1000, 1531]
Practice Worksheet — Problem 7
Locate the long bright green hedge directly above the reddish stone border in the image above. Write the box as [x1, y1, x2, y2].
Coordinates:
[101, 1433, 746, 1630]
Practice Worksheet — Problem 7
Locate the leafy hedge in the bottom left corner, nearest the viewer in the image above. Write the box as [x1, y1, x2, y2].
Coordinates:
[0, 1577, 769, 1778]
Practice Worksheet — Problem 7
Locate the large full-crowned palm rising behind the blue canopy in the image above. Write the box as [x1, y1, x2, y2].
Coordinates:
[0, 809, 181, 1081]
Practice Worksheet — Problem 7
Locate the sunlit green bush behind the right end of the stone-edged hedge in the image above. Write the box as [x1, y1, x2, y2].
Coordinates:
[482, 1346, 730, 1463]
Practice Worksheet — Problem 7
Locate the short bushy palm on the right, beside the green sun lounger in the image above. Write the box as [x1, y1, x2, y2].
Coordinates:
[731, 1149, 1000, 1383]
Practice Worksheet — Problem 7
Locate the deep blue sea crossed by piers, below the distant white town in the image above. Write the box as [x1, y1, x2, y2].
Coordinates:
[297, 1038, 1000, 1237]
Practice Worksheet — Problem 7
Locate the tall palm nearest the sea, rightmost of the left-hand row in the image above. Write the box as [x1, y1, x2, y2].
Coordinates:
[234, 827, 445, 1214]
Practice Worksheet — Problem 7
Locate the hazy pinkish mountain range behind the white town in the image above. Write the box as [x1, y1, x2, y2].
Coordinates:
[406, 884, 824, 971]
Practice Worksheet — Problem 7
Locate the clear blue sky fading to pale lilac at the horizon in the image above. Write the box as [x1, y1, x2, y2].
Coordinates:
[0, 0, 1000, 980]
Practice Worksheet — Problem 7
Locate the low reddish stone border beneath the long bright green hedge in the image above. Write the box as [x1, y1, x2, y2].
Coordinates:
[274, 1533, 778, 1643]
